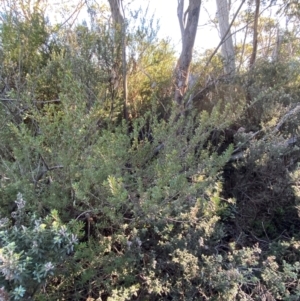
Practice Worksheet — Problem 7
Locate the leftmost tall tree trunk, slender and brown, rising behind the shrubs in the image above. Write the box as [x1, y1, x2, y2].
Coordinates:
[108, 0, 128, 120]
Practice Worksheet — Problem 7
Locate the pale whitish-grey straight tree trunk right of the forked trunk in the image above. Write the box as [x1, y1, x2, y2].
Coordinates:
[216, 0, 235, 75]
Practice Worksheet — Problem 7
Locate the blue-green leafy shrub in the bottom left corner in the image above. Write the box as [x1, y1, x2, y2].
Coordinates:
[0, 193, 78, 300]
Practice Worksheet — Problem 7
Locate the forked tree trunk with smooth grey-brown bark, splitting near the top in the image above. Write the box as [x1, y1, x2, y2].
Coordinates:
[175, 0, 201, 110]
